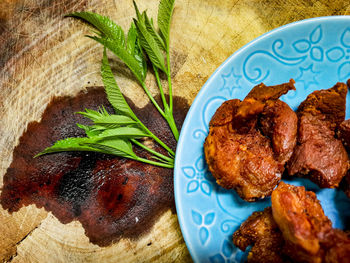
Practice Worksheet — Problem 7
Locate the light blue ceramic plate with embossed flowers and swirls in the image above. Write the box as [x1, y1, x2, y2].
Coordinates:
[175, 16, 350, 262]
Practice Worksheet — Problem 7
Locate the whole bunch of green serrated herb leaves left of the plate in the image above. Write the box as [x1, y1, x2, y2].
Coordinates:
[35, 0, 179, 168]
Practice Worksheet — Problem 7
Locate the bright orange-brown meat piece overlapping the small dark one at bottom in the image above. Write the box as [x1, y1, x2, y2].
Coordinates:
[271, 182, 332, 262]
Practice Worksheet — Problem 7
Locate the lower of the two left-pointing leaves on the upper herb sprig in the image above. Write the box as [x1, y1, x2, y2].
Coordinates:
[88, 36, 146, 83]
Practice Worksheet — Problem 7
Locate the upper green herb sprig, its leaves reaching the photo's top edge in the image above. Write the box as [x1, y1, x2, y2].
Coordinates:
[67, 0, 179, 140]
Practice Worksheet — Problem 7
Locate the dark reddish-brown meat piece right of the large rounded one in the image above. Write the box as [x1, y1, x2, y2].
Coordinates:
[287, 83, 349, 188]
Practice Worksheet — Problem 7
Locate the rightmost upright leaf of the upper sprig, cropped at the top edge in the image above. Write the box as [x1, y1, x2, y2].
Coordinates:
[158, 0, 175, 51]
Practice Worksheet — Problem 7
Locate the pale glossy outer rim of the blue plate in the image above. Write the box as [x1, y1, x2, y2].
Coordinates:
[174, 15, 350, 262]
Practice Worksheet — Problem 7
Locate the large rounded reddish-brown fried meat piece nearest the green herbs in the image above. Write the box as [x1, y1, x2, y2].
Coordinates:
[204, 80, 297, 201]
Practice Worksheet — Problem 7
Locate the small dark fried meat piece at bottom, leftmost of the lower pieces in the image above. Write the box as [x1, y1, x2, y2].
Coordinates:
[233, 207, 288, 263]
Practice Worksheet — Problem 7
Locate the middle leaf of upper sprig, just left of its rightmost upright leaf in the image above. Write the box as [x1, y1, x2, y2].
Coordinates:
[134, 19, 167, 73]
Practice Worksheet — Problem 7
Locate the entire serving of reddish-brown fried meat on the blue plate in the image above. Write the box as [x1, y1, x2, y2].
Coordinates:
[204, 80, 350, 262]
